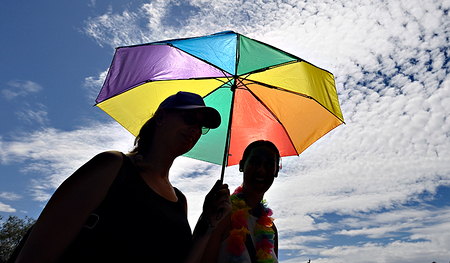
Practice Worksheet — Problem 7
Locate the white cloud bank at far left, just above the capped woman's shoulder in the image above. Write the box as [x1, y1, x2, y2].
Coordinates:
[0, 123, 133, 201]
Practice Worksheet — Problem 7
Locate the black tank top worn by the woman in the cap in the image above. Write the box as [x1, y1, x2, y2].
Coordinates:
[61, 155, 192, 262]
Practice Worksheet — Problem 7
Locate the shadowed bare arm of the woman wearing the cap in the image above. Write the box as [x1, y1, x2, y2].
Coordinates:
[16, 152, 123, 262]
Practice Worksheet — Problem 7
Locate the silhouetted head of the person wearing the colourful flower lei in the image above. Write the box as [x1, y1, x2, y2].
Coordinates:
[239, 141, 280, 194]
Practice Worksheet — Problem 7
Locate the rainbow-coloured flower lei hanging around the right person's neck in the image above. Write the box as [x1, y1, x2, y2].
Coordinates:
[227, 186, 275, 263]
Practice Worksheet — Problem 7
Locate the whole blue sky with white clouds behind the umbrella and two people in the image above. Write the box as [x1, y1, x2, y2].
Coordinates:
[0, 0, 450, 263]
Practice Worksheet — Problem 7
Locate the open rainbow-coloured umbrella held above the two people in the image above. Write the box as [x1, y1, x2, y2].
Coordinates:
[96, 31, 344, 179]
